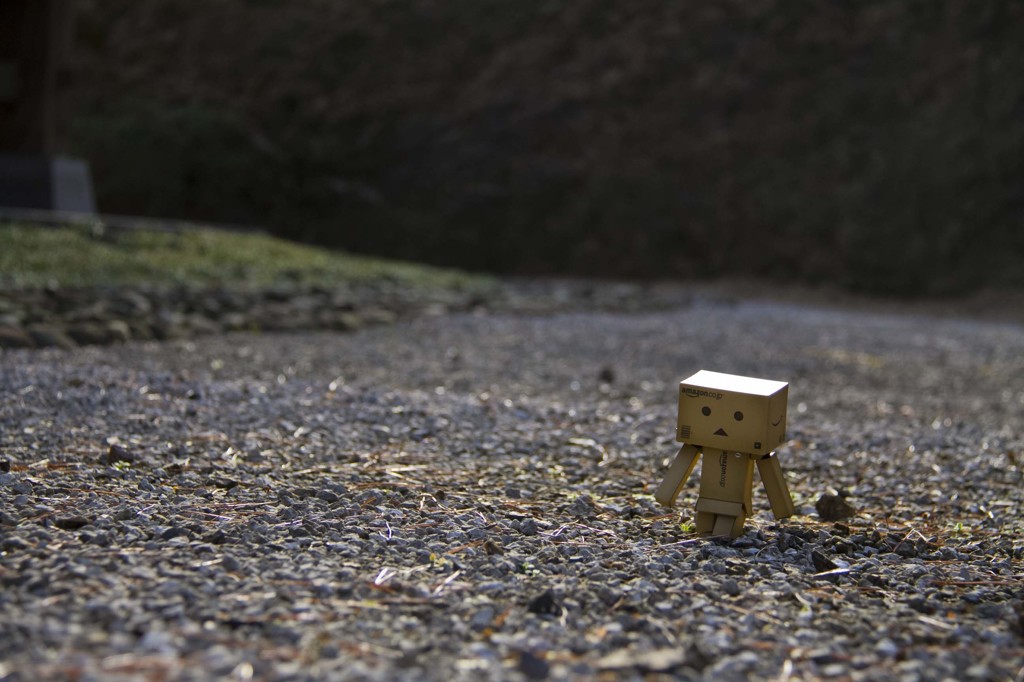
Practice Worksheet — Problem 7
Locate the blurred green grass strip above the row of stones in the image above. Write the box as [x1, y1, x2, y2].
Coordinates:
[0, 223, 493, 290]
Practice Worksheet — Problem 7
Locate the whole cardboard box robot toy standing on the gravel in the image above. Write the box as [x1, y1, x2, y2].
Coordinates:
[654, 370, 796, 538]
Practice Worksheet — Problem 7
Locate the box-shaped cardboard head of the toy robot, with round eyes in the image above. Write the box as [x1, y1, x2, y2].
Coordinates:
[676, 370, 790, 455]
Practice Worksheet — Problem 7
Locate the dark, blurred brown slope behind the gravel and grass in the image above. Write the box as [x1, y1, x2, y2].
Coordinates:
[48, 0, 1024, 295]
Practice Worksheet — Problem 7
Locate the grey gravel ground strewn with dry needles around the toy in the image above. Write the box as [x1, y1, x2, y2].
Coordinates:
[0, 288, 1024, 681]
